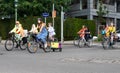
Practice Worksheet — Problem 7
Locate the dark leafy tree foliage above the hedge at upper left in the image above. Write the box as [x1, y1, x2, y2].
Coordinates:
[0, 0, 70, 17]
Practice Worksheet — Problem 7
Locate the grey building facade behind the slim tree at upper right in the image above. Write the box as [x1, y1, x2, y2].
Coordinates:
[69, 0, 120, 29]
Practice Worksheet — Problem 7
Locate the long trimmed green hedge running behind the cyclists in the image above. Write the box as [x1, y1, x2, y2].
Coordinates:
[0, 16, 96, 40]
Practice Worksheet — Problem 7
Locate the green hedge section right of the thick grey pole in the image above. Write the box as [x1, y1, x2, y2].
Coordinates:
[64, 18, 96, 40]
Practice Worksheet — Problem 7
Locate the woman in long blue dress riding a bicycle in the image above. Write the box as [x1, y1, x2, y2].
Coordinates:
[36, 18, 48, 48]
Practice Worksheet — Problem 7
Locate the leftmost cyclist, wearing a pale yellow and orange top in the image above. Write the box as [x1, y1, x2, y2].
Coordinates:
[9, 21, 26, 48]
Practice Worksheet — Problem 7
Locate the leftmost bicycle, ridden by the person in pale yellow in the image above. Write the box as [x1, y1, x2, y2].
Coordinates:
[5, 33, 27, 51]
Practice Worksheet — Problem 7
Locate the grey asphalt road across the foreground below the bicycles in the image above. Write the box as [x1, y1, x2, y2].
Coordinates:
[0, 42, 120, 73]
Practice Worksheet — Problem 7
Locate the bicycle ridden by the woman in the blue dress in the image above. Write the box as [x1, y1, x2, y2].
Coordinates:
[27, 33, 51, 53]
